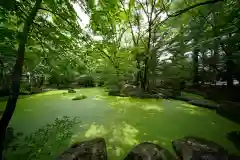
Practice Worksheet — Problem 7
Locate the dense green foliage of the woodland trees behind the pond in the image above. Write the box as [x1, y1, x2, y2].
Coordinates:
[0, 0, 240, 94]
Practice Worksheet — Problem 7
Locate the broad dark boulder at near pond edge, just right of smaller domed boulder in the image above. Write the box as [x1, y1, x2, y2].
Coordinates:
[172, 137, 228, 160]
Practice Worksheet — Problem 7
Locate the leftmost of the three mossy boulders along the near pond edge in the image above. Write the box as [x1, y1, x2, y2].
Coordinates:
[57, 138, 107, 160]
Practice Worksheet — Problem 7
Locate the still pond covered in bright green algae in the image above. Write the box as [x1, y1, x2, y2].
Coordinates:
[0, 88, 240, 160]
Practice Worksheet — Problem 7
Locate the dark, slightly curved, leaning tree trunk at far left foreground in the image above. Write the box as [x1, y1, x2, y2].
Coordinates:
[0, 0, 42, 160]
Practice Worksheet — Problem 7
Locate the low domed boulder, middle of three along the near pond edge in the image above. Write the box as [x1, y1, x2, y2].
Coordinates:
[124, 142, 175, 160]
